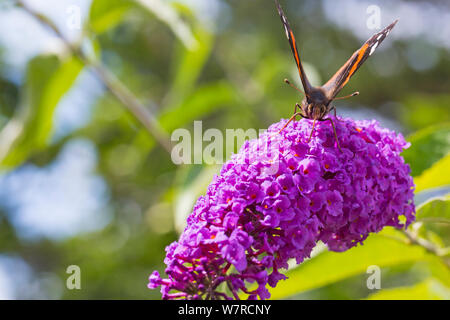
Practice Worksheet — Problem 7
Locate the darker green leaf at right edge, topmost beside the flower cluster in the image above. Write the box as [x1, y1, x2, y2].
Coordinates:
[402, 123, 450, 177]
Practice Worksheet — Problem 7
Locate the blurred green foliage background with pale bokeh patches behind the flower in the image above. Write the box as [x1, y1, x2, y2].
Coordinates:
[0, 0, 450, 299]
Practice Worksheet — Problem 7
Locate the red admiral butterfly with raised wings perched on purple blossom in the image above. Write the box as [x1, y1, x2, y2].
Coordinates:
[275, 0, 398, 150]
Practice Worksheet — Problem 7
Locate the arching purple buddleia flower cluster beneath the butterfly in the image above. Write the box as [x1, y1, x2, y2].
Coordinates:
[148, 118, 415, 299]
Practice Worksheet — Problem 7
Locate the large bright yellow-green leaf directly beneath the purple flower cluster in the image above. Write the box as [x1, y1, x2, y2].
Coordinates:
[270, 234, 427, 299]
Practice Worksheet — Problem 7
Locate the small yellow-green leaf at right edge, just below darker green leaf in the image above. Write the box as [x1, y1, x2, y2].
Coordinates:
[414, 153, 450, 192]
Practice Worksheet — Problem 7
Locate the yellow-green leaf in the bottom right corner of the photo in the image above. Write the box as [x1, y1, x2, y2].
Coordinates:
[368, 278, 450, 300]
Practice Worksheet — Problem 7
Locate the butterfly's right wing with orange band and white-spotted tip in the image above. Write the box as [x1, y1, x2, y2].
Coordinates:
[322, 20, 398, 100]
